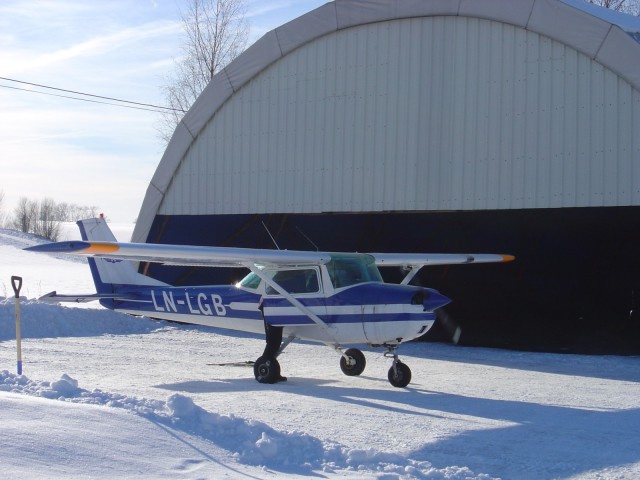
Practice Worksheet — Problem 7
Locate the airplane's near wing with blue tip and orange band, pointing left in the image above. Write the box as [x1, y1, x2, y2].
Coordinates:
[25, 240, 331, 267]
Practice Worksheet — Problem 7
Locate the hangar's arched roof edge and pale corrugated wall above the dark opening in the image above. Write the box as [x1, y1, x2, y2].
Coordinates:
[133, 0, 640, 241]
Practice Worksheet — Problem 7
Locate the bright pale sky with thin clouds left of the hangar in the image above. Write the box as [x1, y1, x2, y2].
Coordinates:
[0, 0, 326, 222]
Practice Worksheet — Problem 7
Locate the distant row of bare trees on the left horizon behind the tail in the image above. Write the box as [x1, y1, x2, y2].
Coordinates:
[0, 191, 98, 242]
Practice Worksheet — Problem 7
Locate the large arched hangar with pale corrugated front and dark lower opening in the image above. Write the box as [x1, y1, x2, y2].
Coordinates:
[133, 0, 640, 353]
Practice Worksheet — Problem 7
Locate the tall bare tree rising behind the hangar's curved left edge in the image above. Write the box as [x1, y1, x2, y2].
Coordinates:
[158, 0, 249, 144]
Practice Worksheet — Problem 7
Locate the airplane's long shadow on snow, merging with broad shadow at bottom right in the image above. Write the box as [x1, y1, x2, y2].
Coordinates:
[157, 377, 640, 479]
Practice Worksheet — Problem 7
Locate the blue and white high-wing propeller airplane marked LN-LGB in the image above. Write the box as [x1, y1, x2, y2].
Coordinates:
[25, 218, 514, 388]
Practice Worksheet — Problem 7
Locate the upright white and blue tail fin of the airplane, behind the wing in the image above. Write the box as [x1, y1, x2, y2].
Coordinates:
[77, 218, 167, 294]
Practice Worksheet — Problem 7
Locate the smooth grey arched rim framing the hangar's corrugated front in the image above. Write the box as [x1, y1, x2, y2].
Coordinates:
[133, 0, 640, 241]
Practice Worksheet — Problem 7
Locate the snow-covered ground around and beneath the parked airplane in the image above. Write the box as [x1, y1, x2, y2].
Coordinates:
[0, 226, 640, 479]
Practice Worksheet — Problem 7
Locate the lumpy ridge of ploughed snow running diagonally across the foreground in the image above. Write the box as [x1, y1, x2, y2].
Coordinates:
[0, 370, 491, 479]
